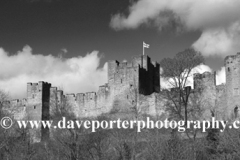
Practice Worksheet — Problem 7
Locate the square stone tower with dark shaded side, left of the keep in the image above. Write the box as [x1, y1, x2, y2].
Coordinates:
[26, 81, 51, 142]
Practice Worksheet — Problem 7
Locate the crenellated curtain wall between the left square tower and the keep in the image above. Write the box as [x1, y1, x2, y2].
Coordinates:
[50, 84, 110, 117]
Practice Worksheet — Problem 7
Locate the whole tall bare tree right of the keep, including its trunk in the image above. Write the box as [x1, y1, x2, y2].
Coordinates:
[160, 48, 204, 159]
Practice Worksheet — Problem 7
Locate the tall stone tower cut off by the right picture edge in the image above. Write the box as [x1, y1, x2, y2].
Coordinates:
[224, 52, 240, 118]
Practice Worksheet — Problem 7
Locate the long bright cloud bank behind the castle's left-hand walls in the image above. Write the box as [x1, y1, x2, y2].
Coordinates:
[0, 46, 107, 98]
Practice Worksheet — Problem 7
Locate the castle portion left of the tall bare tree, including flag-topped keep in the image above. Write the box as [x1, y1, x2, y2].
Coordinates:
[5, 55, 160, 141]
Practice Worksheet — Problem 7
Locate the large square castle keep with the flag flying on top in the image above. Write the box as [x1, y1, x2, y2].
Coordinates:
[108, 55, 160, 108]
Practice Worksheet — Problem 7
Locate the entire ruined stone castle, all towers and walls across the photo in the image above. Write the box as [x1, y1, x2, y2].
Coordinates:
[3, 53, 240, 141]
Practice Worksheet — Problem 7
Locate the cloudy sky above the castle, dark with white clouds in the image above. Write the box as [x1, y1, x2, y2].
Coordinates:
[0, 0, 240, 98]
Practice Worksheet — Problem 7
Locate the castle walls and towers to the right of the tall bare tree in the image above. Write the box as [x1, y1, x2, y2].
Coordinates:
[194, 53, 240, 120]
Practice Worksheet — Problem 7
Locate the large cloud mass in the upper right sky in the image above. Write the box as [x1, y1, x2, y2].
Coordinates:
[110, 0, 240, 57]
